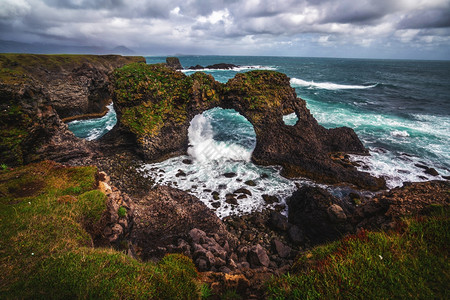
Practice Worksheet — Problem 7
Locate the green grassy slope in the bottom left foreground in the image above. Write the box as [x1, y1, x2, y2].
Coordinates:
[0, 162, 200, 299]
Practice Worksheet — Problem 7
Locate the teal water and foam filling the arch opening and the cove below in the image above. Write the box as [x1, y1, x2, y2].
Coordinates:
[144, 107, 295, 218]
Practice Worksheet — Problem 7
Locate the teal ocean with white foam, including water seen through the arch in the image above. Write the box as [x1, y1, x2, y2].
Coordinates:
[69, 56, 450, 217]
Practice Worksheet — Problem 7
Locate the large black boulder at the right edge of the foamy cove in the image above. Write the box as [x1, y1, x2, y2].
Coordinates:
[287, 186, 354, 244]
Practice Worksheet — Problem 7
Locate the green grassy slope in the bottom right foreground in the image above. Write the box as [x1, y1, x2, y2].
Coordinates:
[267, 207, 450, 299]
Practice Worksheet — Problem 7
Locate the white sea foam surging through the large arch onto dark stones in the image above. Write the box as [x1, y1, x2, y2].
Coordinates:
[143, 108, 296, 218]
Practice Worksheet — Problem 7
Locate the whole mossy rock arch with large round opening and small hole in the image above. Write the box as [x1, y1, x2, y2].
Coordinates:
[110, 64, 384, 190]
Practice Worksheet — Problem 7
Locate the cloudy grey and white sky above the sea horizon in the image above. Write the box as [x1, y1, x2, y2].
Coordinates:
[0, 0, 450, 60]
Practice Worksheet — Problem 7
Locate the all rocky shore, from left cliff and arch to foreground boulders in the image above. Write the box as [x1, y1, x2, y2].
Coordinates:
[0, 55, 450, 299]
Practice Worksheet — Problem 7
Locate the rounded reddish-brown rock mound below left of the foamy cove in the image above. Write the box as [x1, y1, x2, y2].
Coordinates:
[130, 186, 227, 259]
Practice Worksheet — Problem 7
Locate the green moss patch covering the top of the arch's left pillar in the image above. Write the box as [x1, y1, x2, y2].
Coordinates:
[114, 64, 192, 136]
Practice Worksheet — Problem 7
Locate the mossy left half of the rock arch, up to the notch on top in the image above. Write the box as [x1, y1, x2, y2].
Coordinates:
[110, 64, 222, 160]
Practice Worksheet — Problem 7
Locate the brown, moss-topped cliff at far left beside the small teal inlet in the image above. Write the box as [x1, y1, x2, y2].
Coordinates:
[0, 54, 145, 166]
